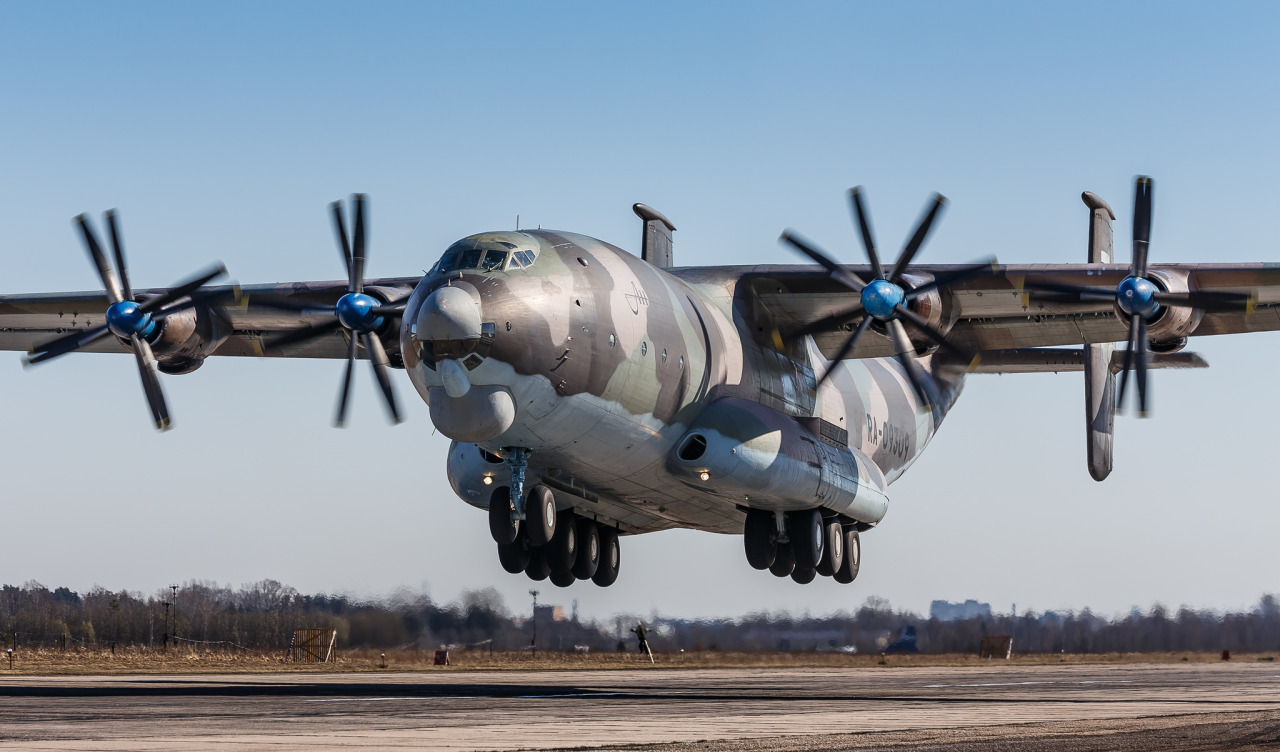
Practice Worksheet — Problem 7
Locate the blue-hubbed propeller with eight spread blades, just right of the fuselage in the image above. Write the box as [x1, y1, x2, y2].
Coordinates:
[781, 187, 996, 412]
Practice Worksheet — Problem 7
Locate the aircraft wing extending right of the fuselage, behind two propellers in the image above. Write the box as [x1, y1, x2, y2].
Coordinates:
[732, 263, 1280, 358]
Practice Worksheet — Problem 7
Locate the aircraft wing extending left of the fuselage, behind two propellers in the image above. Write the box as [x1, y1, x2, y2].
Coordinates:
[0, 278, 419, 359]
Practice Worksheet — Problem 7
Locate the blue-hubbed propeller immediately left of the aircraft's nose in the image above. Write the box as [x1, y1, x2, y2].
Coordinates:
[253, 193, 404, 427]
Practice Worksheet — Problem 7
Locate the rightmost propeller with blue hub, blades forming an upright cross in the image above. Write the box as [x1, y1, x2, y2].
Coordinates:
[1023, 175, 1256, 417]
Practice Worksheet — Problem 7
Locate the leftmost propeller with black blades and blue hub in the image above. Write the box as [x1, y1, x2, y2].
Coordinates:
[27, 210, 227, 431]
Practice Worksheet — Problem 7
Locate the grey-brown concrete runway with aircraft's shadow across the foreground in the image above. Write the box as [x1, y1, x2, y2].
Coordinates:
[0, 662, 1280, 752]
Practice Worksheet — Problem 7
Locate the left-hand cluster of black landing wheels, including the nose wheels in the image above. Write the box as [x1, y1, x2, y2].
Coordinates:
[489, 486, 622, 587]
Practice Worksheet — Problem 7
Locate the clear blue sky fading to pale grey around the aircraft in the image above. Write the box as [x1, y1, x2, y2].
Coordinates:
[0, 3, 1280, 616]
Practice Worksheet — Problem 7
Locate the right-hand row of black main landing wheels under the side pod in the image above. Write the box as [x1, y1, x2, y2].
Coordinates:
[742, 509, 863, 584]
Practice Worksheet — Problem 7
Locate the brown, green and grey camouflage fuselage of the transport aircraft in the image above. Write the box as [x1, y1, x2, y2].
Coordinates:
[401, 230, 961, 533]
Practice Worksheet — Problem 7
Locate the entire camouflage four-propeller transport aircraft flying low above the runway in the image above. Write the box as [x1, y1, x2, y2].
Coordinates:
[0, 178, 1280, 586]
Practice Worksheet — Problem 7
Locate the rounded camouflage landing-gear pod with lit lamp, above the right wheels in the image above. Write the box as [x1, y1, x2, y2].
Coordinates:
[667, 396, 888, 524]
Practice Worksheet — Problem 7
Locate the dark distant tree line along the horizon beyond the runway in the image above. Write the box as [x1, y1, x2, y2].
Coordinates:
[0, 579, 1280, 654]
